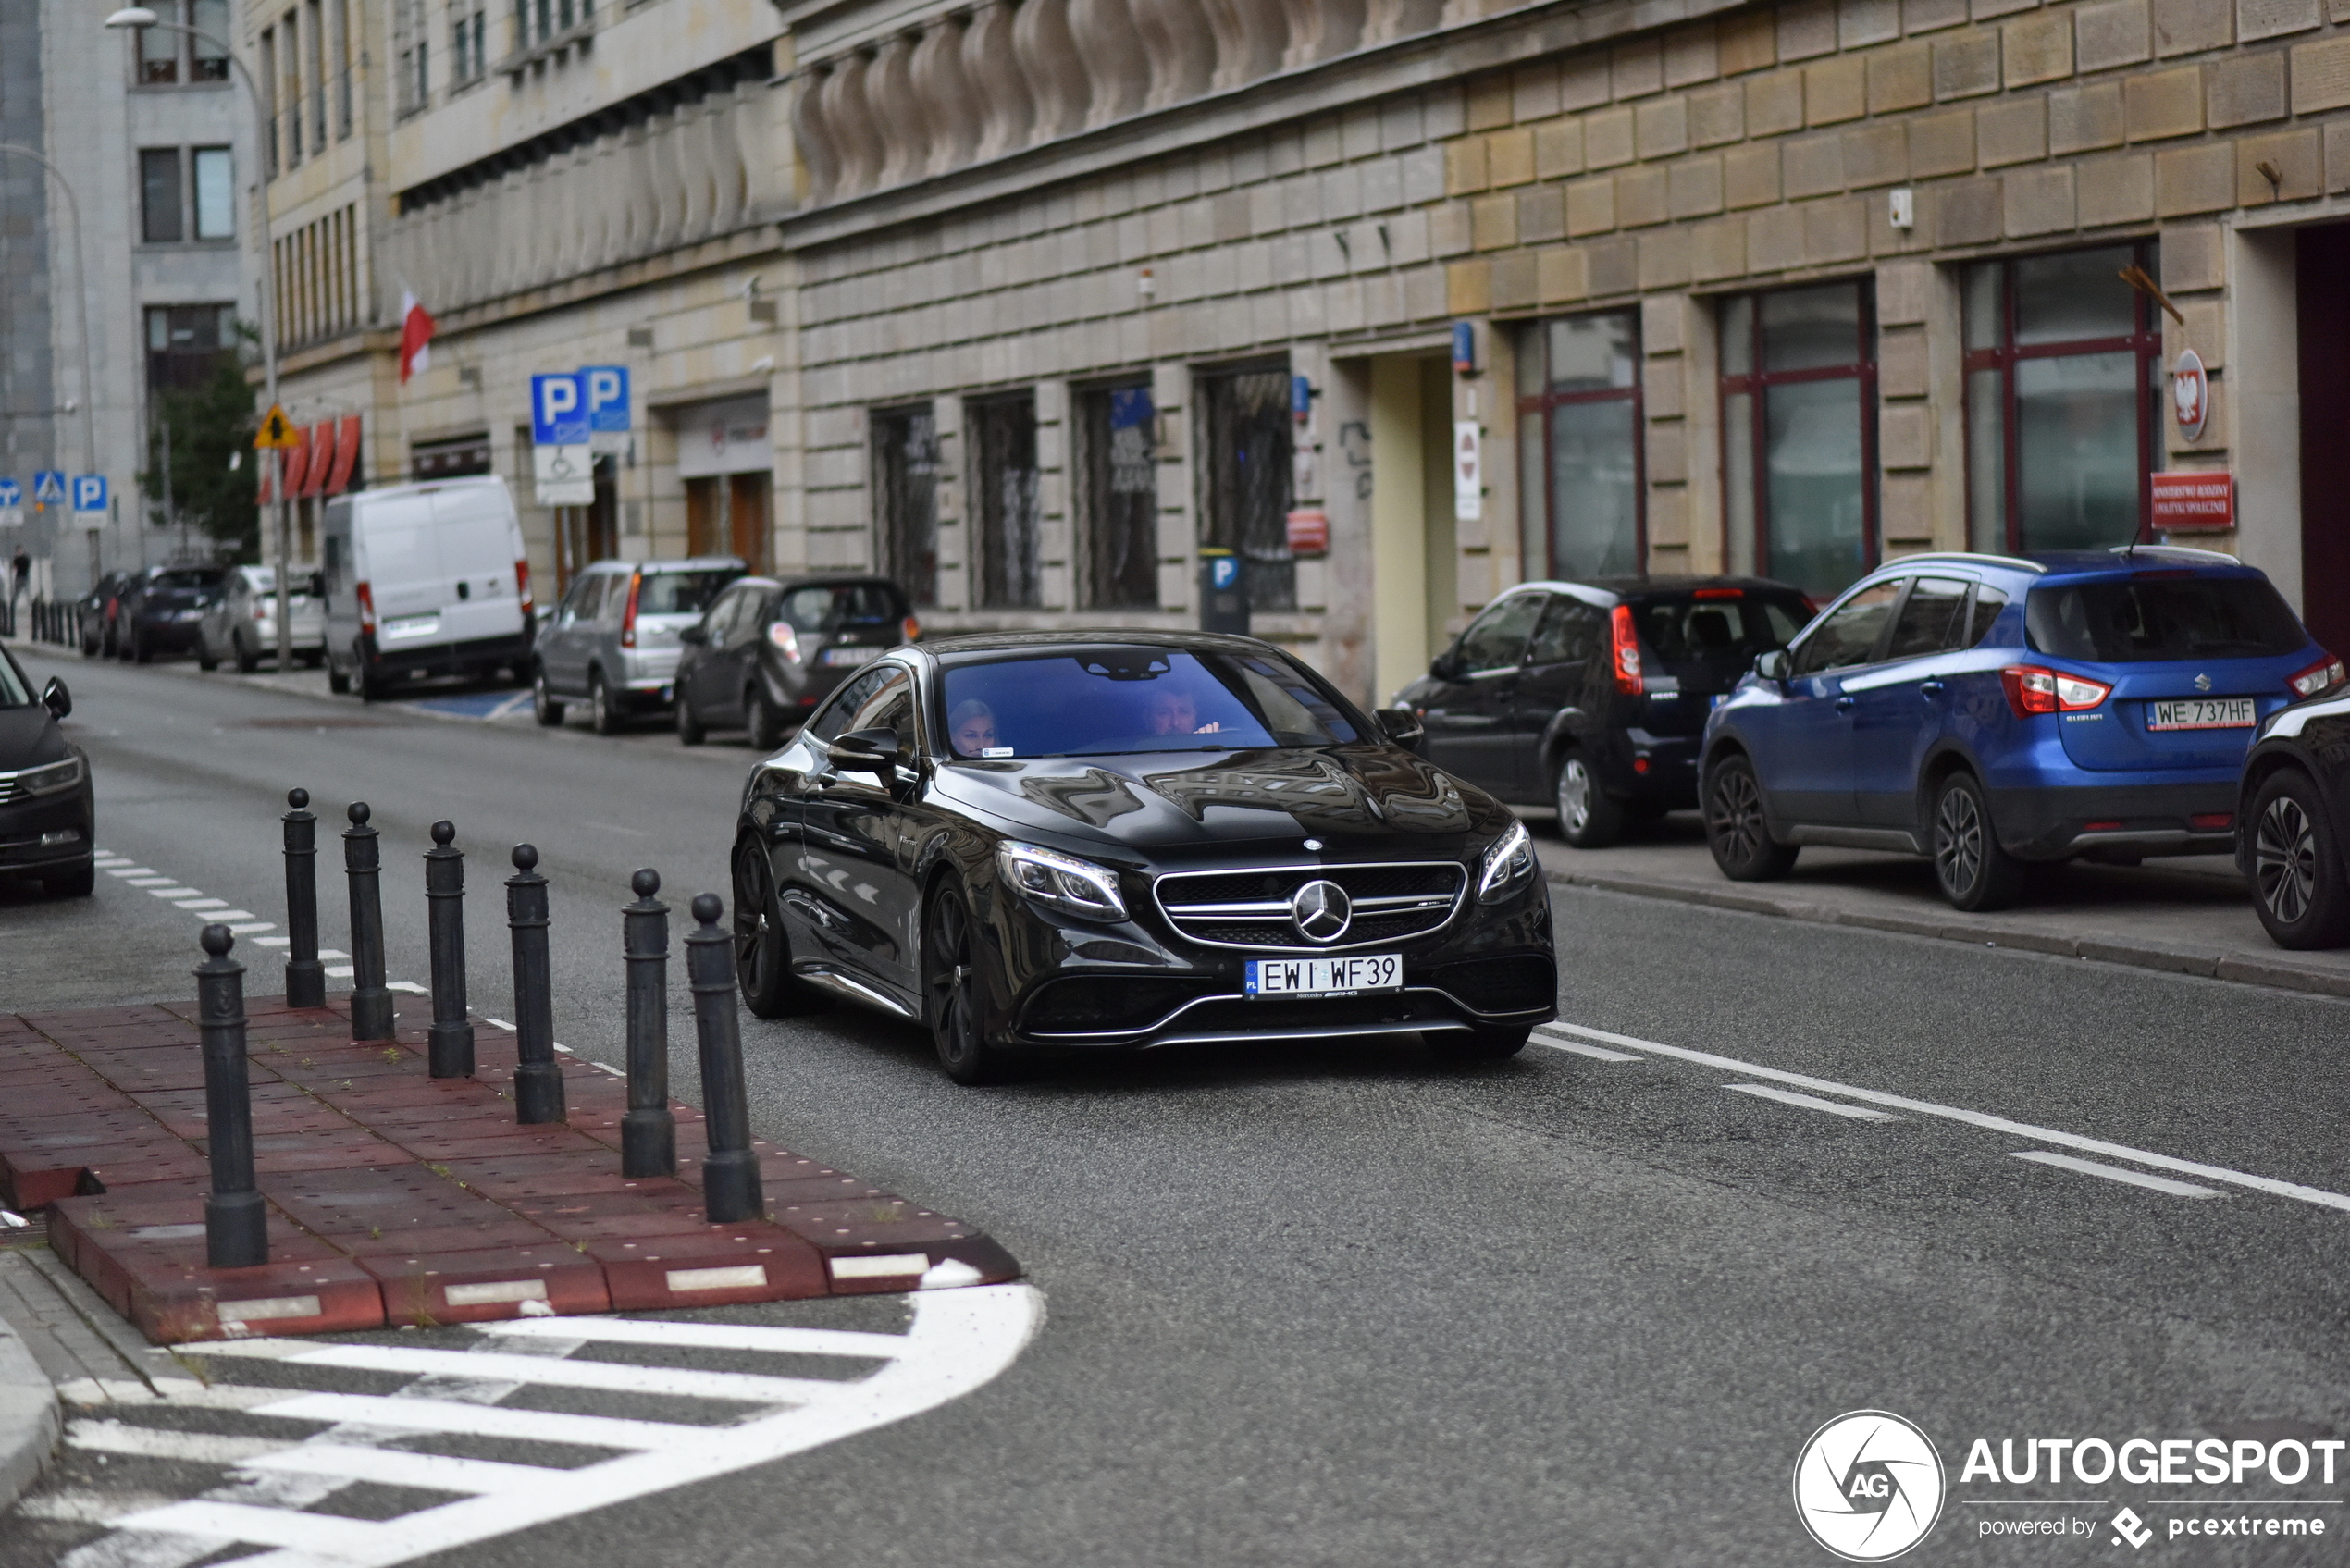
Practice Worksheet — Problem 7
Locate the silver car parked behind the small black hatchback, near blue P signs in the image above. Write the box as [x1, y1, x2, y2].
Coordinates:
[531, 555, 749, 735]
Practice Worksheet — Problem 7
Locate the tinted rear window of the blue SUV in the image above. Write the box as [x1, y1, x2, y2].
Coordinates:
[2023, 572, 2310, 665]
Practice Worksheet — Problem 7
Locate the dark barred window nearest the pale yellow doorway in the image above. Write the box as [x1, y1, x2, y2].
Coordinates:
[1198, 366, 1297, 611]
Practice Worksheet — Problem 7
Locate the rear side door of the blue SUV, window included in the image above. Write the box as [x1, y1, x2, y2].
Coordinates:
[1845, 576, 1972, 828]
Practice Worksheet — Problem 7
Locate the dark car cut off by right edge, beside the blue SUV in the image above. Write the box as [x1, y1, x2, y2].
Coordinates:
[2235, 681, 2350, 947]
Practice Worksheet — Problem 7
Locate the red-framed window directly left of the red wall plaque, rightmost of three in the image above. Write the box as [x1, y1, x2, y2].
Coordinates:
[1962, 240, 2162, 552]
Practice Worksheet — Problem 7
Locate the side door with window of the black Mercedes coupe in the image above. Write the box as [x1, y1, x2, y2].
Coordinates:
[799, 663, 921, 1013]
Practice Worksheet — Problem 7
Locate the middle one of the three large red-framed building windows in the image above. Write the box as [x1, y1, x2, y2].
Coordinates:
[1720, 282, 1877, 595]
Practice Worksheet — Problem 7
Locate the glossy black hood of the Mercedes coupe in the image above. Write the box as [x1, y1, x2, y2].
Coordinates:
[933, 746, 1509, 853]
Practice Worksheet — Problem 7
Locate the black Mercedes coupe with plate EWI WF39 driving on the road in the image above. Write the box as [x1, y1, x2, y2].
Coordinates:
[733, 630, 1558, 1084]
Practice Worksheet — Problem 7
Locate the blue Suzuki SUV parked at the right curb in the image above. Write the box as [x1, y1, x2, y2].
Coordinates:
[1701, 546, 2343, 909]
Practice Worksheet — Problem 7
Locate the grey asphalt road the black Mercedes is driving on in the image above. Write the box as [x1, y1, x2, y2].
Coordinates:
[0, 659, 2350, 1568]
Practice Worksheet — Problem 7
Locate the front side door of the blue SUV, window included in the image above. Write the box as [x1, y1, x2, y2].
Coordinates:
[1739, 578, 1901, 825]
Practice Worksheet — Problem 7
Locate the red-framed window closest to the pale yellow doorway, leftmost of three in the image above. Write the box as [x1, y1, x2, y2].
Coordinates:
[1518, 310, 1648, 578]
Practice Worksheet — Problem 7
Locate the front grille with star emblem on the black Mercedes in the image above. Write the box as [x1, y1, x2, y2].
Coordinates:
[1154, 860, 1469, 952]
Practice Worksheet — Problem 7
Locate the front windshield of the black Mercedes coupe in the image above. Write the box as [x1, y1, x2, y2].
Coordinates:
[945, 644, 1361, 757]
